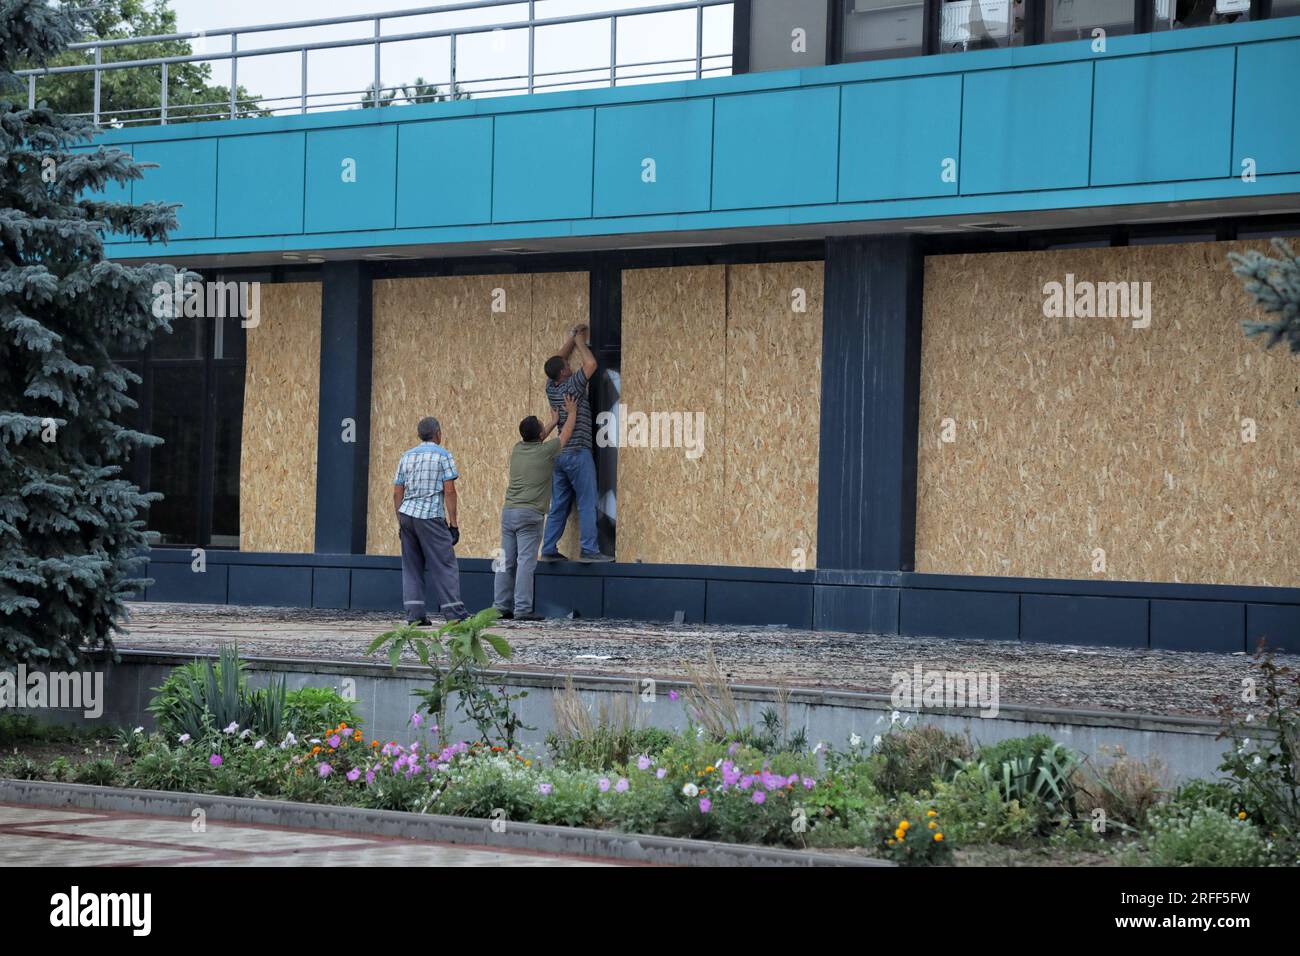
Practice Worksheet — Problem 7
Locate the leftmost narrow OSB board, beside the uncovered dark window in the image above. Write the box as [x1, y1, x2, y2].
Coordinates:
[239, 282, 321, 553]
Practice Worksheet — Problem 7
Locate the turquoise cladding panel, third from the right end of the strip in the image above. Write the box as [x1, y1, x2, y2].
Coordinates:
[958, 62, 1092, 195]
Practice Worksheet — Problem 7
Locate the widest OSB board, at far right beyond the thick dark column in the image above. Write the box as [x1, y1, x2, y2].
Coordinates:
[917, 243, 1300, 587]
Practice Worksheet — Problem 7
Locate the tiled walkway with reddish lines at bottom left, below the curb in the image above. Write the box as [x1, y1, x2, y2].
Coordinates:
[0, 804, 618, 868]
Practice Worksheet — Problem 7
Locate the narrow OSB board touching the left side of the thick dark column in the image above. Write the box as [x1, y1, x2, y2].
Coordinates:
[712, 263, 823, 568]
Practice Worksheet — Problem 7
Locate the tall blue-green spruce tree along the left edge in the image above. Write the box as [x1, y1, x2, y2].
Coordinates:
[0, 0, 183, 669]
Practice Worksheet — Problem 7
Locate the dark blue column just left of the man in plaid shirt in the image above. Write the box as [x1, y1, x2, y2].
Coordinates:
[316, 263, 372, 554]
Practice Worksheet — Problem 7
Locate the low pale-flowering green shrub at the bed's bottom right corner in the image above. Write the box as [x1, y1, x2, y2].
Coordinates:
[1141, 806, 1270, 866]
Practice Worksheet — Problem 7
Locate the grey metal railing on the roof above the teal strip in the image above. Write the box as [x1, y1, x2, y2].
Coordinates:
[17, 0, 735, 126]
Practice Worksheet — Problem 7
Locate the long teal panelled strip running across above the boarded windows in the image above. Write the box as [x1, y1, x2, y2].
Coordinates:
[89, 17, 1300, 258]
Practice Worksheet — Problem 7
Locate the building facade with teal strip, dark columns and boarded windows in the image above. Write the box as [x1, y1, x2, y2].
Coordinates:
[100, 0, 1300, 652]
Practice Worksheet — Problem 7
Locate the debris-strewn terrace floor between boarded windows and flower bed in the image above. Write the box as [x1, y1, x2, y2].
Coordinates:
[118, 604, 1300, 717]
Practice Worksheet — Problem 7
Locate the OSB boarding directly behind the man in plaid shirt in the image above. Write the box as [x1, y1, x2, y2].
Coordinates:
[365, 273, 589, 558]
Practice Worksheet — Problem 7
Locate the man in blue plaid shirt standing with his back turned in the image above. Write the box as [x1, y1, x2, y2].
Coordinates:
[393, 418, 469, 627]
